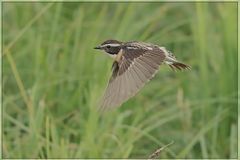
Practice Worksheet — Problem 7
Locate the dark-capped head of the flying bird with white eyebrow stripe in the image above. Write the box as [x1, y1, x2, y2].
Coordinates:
[94, 40, 122, 54]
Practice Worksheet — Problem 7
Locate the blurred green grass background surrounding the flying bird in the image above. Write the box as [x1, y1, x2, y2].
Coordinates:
[2, 2, 238, 158]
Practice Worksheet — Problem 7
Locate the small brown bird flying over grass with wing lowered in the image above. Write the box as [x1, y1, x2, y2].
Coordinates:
[94, 40, 190, 111]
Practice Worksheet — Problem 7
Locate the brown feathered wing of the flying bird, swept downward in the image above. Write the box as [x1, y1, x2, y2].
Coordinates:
[100, 46, 165, 110]
